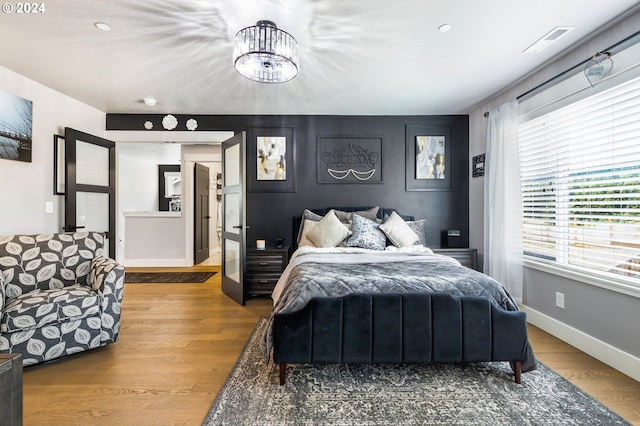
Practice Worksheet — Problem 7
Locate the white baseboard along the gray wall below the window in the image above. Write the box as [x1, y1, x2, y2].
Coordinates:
[520, 305, 640, 382]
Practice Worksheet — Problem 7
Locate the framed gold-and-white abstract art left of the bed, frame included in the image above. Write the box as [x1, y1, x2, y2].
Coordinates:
[247, 127, 296, 192]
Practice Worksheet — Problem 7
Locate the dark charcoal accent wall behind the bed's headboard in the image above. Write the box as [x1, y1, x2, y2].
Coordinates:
[106, 114, 470, 247]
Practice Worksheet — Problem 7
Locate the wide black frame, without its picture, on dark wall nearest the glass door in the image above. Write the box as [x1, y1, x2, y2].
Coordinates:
[247, 126, 297, 192]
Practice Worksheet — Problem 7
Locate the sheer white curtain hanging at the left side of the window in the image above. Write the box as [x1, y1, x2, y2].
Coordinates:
[484, 100, 522, 302]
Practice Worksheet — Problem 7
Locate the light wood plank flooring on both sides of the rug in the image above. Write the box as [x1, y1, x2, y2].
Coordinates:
[21, 266, 640, 426]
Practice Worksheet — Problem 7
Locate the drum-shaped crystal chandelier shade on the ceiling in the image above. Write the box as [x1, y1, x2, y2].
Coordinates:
[233, 21, 300, 83]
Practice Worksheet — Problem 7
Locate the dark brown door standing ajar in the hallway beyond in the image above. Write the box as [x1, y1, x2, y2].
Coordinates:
[193, 163, 211, 265]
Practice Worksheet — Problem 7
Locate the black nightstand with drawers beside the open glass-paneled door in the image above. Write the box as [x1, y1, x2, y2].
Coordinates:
[244, 246, 289, 296]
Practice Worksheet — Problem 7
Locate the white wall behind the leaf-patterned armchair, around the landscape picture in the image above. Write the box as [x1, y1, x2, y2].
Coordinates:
[0, 66, 105, 235]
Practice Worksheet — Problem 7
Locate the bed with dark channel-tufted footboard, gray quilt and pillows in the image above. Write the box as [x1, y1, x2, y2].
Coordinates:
[263, 207, 536, 385]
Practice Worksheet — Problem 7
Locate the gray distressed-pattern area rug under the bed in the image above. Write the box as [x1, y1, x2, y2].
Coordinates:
[203, 319, 629, 426]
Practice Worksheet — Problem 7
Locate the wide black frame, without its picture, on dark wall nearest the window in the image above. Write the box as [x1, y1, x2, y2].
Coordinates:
[405, 125, 453, 191]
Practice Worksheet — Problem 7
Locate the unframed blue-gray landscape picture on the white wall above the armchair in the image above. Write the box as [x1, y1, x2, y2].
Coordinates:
[0, 90, 33, 163]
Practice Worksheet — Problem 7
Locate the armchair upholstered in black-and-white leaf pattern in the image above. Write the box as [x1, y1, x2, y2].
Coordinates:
[0, 232, 124, 365]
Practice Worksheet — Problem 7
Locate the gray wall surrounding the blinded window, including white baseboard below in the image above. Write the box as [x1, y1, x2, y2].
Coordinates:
[469, 12, 640, 380]
